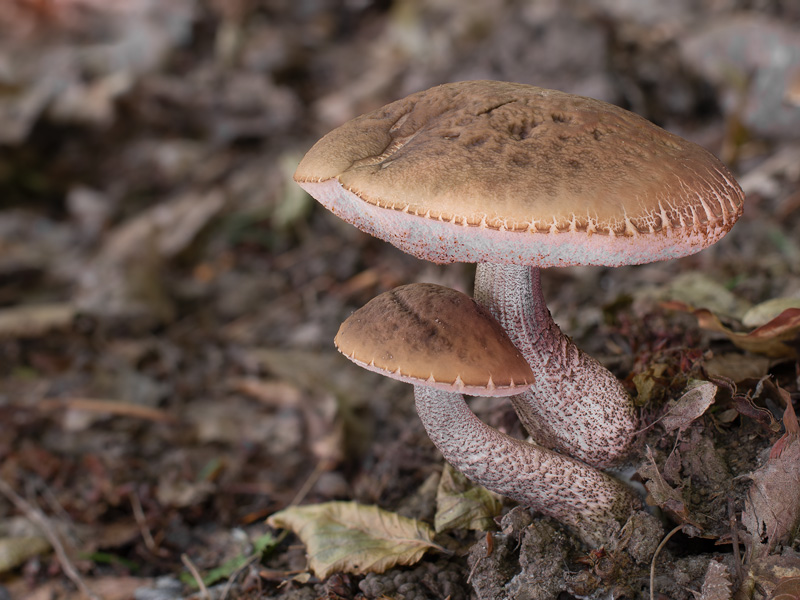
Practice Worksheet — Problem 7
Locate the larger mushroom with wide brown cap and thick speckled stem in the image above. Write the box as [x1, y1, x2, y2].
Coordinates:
[294, 81, 743, 467]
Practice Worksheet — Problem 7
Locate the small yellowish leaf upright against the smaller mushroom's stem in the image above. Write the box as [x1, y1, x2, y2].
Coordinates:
[434, 463, 503, 533]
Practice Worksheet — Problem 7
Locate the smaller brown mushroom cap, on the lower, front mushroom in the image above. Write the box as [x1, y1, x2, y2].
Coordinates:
[334, 283, 533, 396]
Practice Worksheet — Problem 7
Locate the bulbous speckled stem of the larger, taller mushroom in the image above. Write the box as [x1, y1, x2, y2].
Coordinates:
[475, 264, 637, 468]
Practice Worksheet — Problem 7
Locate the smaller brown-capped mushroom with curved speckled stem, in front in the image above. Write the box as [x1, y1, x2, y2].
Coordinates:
[335, 283, 639, 547]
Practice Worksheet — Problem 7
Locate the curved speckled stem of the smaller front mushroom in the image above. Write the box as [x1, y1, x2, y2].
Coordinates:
[414, 386, 639, 547]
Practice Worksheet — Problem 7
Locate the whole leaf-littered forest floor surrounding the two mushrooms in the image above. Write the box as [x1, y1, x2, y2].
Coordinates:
[0, 0, 800, 600]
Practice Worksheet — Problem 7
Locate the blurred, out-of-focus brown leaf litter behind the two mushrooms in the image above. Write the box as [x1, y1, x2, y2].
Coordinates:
[0, 0, 800, 599]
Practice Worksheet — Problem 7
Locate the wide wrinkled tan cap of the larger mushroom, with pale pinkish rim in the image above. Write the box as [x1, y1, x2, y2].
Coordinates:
[294, 81, 743, 266]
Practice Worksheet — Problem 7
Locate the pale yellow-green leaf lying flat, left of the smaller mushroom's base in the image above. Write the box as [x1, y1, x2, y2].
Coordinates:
[267, 502, 440, 579]
